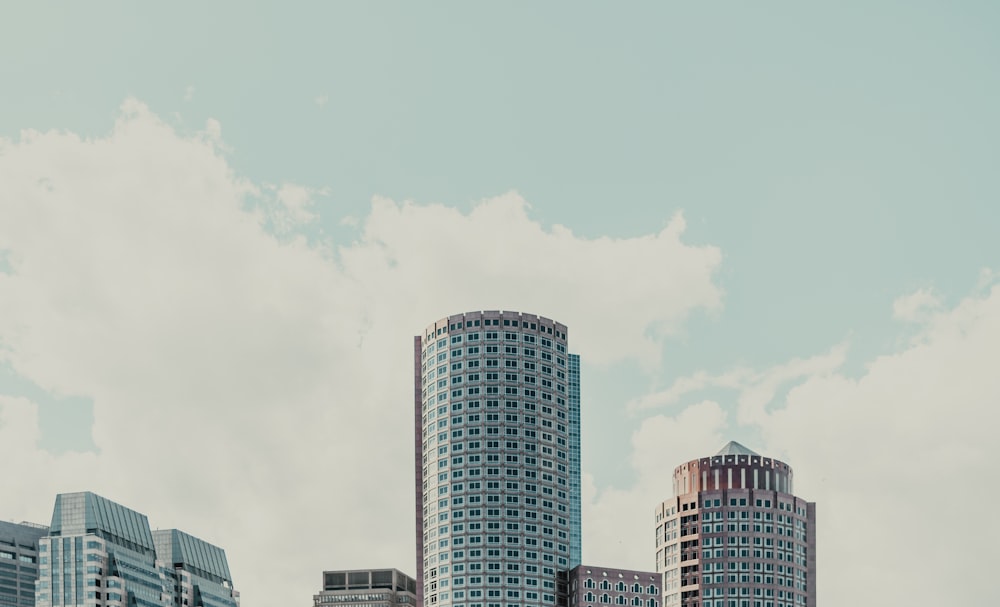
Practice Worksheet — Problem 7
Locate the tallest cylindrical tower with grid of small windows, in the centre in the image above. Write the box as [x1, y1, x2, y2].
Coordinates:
[413, 311, 580, 607]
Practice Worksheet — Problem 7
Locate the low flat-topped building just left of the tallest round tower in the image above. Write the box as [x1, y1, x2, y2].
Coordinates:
[313, 569, 417, 607]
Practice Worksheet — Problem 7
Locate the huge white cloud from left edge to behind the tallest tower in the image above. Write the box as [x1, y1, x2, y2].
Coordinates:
[0, 100, 720, 605]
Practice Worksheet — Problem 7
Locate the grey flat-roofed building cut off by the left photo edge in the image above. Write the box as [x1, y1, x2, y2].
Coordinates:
[0, 521, 49, 607]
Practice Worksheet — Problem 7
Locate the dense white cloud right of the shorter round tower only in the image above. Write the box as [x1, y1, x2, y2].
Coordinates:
[762, 286, 1000, 605]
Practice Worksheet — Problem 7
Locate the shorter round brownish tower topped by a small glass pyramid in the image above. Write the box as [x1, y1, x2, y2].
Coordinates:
[655, 442, 816, 607]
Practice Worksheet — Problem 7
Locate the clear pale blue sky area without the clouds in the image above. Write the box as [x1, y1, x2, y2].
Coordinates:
[0, 1, 1000, 604]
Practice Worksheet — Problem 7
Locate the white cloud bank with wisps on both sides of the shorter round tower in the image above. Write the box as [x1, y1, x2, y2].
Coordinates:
[584, 281, 1000, 605]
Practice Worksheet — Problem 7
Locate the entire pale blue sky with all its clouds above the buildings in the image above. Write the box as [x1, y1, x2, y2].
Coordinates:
[0, 0, 1000, 607]
